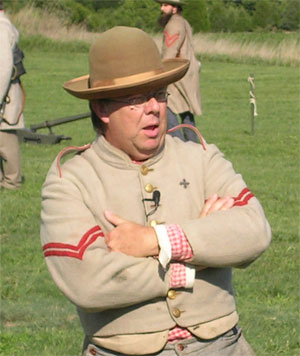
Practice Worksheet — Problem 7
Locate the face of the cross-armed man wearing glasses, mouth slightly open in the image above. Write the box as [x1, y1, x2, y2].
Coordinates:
[94, 88, 167, 161]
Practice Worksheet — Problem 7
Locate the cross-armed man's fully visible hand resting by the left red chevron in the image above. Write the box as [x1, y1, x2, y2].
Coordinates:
[104, 210, 159, 257]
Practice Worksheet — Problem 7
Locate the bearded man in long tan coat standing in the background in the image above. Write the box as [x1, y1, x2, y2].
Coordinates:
[156, 0, 202, 142]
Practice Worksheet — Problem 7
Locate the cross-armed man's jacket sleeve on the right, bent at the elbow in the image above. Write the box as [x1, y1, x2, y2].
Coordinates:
[181, 145, 271, 268]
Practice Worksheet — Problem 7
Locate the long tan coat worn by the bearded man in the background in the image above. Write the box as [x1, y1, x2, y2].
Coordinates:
[162, 14, 202, 115]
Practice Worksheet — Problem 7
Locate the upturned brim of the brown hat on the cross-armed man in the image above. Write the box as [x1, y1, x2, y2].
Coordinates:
[63, 58, 189, 100]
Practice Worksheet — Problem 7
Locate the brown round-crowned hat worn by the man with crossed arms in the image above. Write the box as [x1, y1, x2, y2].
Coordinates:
[63, 26, 189, 100]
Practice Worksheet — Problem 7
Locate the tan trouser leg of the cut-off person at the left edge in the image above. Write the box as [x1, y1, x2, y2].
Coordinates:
[0, 130, 22, 189]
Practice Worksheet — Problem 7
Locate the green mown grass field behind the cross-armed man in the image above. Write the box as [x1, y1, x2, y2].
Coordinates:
[0, 37, 299, 356]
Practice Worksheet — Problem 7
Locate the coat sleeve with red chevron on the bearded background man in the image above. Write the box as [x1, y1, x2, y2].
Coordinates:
[162, 16, 186, 59]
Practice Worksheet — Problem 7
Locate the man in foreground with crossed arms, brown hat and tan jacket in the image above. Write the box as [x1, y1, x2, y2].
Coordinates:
[41, 26, 271, 356]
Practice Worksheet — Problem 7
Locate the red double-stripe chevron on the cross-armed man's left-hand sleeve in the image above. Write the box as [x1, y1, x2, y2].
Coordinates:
[43, 226, 104, 260]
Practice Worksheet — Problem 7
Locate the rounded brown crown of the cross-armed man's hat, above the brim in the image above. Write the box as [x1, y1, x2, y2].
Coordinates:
[89, 26, 162, 88]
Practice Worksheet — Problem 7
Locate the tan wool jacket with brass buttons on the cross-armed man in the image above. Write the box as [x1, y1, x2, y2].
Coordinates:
[41, 135, 271, 355]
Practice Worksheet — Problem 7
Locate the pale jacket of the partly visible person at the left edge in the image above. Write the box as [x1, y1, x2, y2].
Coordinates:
[0, 11, 24, 130]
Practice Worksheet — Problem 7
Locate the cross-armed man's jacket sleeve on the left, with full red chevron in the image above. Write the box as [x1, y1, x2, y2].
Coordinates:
[41, 162, 170, 311]
